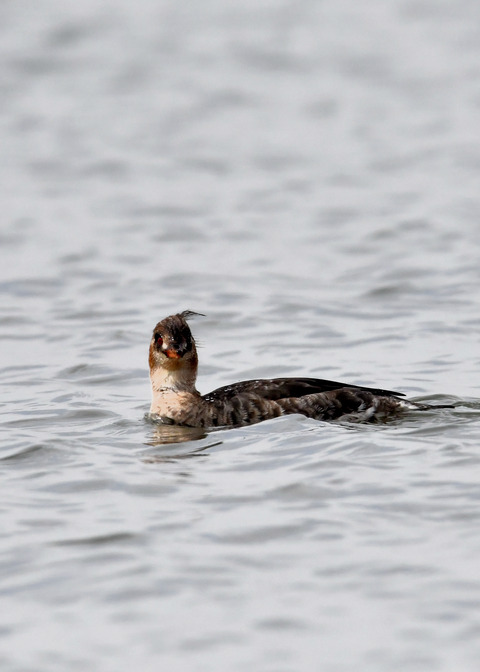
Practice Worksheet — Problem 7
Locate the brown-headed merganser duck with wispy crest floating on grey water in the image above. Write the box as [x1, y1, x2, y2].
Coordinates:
[148, 310, 452, 429]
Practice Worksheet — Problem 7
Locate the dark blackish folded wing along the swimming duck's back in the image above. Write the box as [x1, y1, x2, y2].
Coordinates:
[203, 378, 405, 401]
